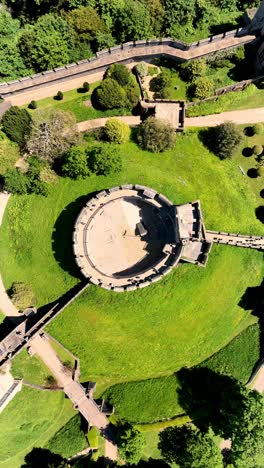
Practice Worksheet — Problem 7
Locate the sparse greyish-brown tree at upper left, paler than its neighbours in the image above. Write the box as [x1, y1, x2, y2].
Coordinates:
[27, 111, 78, 162]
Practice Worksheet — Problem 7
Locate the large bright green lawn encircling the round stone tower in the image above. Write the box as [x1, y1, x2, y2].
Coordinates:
[0, 131, 263, 391]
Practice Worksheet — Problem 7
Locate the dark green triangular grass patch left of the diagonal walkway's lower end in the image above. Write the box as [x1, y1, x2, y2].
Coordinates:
[46, 414, 88, 458]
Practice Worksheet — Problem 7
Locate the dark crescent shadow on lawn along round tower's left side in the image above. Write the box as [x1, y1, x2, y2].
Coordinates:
[52, 192, 97, 279]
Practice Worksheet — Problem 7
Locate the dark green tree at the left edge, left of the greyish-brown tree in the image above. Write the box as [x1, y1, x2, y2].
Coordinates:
[1, 106, 32, 148]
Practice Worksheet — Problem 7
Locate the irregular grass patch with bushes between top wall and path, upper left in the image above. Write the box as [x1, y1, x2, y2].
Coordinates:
[22, 81, 131, 122]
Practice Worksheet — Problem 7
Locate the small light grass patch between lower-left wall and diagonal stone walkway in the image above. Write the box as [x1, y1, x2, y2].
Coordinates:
[12, 349, 51, 385]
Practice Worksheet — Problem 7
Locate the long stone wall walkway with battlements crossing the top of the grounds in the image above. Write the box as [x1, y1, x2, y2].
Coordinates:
[0, 28, 255, 105]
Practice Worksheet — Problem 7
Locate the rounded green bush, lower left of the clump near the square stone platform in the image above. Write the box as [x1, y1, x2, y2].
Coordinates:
[95, 78, 127, 109]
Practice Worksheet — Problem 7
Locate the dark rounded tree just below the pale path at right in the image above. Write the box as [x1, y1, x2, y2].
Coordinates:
[208, 122, 242, 159]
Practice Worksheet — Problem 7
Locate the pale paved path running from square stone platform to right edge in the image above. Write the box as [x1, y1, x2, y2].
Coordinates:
[184, 107, 264, 127]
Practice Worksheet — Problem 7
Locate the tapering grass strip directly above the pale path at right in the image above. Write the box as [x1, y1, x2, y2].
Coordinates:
[186, 84, 264, 117]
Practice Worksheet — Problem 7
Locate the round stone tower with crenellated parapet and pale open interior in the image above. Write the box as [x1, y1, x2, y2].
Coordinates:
[72, 184, 182, 292]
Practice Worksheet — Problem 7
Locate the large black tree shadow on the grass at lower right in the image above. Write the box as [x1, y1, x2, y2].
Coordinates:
[177, 367, 243, 438]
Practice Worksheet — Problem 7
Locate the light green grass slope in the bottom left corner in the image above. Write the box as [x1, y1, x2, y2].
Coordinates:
[0, 387, 75, 468]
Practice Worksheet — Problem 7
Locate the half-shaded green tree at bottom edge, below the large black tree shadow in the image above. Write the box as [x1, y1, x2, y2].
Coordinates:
[159, 425, 224, 468]
